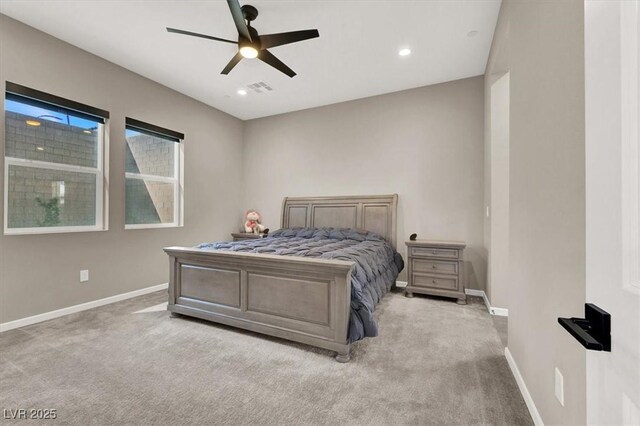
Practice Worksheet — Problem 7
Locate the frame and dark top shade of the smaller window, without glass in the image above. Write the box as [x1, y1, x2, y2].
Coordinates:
[124, 117, 184, 230]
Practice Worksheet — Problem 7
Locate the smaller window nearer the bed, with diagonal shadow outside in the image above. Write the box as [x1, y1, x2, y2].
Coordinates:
[125, 118, 184, 229]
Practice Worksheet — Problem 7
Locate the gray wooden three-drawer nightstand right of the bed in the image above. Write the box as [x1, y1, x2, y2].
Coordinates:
[405, 240, 467, 305]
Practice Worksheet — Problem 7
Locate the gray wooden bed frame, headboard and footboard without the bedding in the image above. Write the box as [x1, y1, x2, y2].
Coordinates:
[164, 194, 398, 362]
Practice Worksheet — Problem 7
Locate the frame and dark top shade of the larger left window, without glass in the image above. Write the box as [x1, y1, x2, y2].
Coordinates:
[2, 81, 109, 235]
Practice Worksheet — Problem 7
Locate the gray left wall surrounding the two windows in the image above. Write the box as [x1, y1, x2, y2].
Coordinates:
[0, 15, 243, 323]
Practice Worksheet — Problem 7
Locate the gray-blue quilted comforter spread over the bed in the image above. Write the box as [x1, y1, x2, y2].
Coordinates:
[198, 228, 404, 342]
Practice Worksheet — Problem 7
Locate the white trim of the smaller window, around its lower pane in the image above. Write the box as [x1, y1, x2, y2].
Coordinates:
[124, 141, 184, 230]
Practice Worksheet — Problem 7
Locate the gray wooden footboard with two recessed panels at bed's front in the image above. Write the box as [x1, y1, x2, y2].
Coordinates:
[164, 247, 353, 362]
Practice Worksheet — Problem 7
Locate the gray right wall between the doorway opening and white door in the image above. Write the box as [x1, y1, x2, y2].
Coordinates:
[485, 0, 586, 425]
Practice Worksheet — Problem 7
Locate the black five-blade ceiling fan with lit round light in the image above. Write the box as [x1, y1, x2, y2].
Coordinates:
[167, 0, 320, 77]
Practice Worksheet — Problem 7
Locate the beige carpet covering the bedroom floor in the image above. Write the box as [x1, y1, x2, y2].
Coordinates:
[0, 291, 532, 425]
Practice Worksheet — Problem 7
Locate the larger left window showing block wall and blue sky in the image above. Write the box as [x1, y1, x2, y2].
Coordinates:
[4, 82, 109, 234]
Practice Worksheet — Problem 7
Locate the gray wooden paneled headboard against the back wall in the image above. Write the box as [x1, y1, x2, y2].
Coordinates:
[281, 194, 398, 248]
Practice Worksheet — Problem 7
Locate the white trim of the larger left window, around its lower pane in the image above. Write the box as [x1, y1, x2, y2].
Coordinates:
[4, 122, 108, 235]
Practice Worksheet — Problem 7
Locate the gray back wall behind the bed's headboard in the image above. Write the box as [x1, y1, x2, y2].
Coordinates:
[244, 77, 486, 289]
